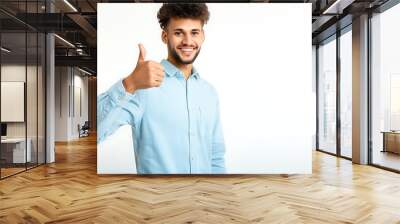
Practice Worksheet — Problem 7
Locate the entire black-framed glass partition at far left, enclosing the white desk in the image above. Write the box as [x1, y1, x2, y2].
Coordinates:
[0, 1, 46, 179]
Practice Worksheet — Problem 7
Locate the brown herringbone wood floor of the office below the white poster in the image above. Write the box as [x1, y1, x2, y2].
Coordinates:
[0, 134, 400, 224]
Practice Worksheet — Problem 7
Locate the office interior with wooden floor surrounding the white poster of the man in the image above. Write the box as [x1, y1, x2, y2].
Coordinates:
[0, 0, 400, 224]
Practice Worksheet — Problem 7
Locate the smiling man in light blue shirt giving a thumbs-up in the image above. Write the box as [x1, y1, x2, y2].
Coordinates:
[98, 3, 225, 174]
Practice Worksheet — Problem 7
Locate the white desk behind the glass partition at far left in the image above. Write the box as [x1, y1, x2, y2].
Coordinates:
[1, 138, 32, 163]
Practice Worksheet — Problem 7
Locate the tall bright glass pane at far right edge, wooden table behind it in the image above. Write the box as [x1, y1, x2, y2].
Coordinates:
[370, 4, 400, 171]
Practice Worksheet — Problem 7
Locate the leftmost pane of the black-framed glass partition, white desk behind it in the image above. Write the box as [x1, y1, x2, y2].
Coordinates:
[0, 32, 27, 178]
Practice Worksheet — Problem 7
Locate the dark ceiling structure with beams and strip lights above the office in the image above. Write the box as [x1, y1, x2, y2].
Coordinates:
[0, 0, 394, 74]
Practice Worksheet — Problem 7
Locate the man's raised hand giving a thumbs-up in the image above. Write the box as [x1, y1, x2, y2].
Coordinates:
[123, 44, 164, 93]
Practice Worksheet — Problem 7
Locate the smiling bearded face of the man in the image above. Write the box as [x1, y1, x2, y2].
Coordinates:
[161, 18, 204, 64]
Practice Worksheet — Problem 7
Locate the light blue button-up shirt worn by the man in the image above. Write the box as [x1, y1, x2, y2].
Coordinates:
[97, 60, 225, 174]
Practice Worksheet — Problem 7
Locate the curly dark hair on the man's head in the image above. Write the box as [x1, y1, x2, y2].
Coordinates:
[157, 3, 210, 29]
